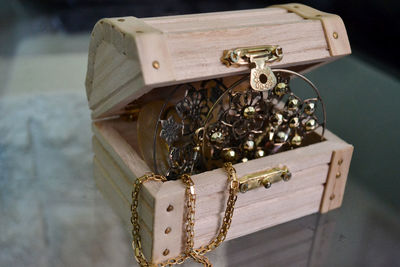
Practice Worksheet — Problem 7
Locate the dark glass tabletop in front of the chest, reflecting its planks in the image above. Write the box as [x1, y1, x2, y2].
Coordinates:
[199, 180, 400, 266]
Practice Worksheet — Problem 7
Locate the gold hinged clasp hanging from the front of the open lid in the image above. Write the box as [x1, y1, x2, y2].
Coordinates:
[221, 45, 283, 91]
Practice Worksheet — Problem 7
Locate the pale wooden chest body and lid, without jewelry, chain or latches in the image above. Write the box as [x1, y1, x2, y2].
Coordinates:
[86, 4, 353, 262]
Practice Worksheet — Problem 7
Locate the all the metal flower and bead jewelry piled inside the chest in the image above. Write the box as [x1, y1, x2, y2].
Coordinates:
[134, 69, 326, 180]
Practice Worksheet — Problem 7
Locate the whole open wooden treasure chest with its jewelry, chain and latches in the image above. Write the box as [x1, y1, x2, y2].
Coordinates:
[86, 4, 353, 265]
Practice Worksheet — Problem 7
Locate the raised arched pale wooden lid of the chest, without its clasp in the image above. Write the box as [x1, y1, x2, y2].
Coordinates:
[86, 8, 350, 118]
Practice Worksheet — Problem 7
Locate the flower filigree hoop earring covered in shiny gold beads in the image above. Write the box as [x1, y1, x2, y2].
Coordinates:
[203, 71, 324, 169]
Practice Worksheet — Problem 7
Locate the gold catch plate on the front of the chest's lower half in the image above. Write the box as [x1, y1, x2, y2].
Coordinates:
[239, 166, 292, 193]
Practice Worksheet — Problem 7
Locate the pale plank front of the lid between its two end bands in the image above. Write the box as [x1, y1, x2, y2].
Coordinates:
[166, 21, 330, 81]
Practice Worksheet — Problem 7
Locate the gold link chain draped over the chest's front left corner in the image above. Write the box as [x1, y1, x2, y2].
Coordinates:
[131, 162, 239, 267]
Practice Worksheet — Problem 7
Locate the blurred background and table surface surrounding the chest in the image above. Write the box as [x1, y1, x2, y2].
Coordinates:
[0, 0, 400, 266]
